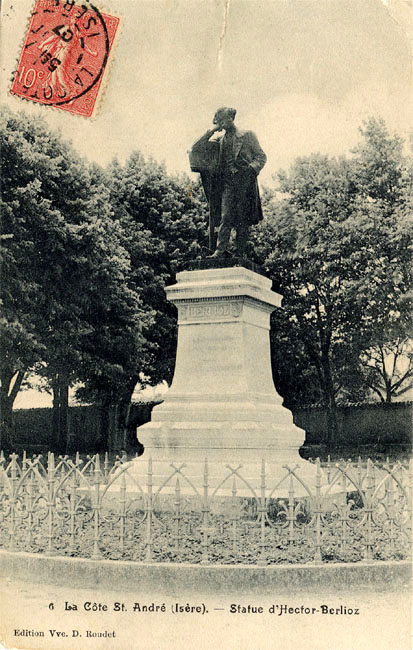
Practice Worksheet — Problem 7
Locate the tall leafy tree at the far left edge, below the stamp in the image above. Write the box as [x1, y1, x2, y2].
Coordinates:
[0, 110, 77, 442]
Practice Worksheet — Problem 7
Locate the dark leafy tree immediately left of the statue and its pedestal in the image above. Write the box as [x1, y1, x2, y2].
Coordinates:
[74, 152, 207, 439]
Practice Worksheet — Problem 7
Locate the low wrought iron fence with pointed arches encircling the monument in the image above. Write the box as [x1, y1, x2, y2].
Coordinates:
[0, 453, 413, 565]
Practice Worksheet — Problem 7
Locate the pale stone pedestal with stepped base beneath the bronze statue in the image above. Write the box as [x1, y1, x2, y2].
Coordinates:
[125, 267, 322, 497]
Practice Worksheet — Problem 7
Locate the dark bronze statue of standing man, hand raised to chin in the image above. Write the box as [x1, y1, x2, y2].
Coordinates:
[190, 107, 267, 257]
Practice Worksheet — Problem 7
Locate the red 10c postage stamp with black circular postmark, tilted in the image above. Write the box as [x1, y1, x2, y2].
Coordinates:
[10, 0, 119, 117]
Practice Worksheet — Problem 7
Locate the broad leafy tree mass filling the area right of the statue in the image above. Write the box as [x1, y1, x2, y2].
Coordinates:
[255, 120, 411, 442]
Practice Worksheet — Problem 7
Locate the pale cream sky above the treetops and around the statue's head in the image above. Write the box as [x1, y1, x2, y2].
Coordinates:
[0, 0, 413, 406]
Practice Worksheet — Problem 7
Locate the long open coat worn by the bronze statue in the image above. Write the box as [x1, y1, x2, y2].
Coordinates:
[190, 129, 267, 226]
